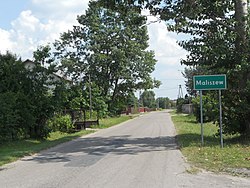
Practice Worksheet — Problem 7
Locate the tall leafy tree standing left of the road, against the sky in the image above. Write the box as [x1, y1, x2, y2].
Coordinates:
[55, 1, 159, 114]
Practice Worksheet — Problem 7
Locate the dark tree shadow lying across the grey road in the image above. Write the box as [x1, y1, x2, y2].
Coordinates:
[23, 135, 178, 166]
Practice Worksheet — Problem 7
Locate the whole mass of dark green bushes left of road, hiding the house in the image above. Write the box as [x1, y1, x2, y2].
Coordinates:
[0, 53, 63, 142]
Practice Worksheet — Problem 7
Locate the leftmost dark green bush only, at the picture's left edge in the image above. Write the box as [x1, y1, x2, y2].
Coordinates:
[0, 53, 35, 142]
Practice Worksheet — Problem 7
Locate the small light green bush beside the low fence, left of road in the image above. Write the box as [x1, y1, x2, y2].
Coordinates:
[48, 115, 74, 133]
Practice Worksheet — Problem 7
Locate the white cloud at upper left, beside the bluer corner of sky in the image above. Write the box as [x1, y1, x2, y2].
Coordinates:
[0, 0, 88, 59]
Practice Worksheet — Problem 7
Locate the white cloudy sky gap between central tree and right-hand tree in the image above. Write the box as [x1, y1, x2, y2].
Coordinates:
[143, 11, 187, 99]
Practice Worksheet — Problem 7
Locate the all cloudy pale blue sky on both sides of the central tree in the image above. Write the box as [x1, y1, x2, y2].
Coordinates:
[0, 0, 187, 99]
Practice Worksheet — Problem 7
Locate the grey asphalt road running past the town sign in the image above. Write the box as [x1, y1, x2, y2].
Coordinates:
[0, 111, 250, 188]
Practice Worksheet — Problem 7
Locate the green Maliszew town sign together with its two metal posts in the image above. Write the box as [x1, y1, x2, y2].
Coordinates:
[193, 74, 227, 148]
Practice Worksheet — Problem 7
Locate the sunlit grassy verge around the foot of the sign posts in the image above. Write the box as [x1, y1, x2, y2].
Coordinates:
[172, 112, 250, 176]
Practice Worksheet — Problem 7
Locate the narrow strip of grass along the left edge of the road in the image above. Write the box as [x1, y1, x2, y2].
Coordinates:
[0, 116, 135, 166]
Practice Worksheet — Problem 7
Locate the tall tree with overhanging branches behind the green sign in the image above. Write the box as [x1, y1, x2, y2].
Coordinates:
[104, 0, 250, 135]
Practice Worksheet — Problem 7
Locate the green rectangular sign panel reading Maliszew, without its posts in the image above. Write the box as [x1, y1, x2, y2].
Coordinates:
[193, 74, 227, 90]
